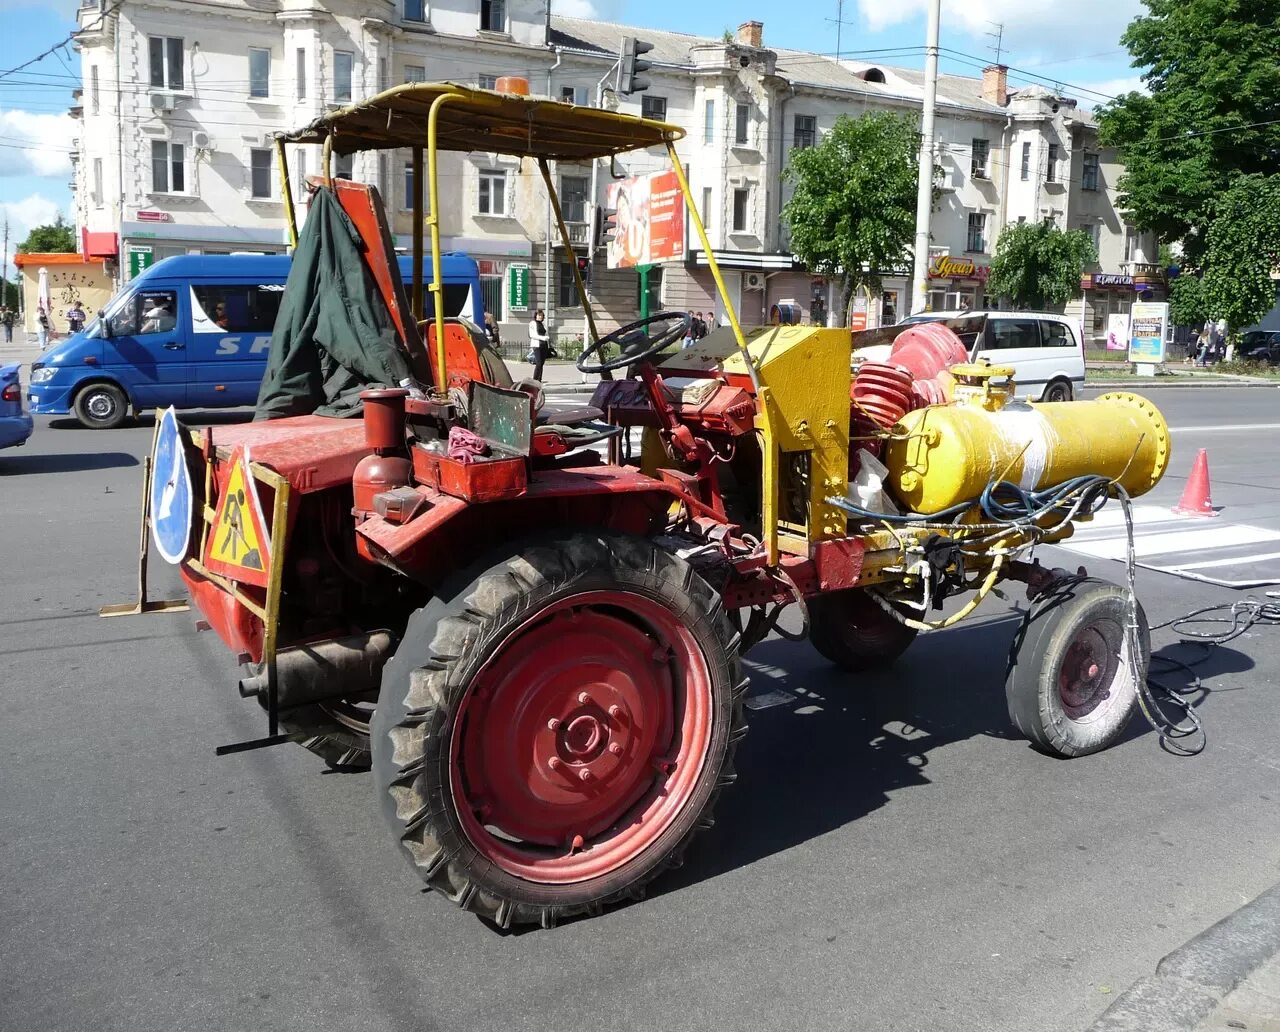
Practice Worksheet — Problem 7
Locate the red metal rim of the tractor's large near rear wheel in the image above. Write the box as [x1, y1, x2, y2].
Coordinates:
[449, 590, 713, 885]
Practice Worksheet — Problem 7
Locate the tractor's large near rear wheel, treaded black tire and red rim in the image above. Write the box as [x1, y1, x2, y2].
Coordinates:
[371, 531, 746, 927]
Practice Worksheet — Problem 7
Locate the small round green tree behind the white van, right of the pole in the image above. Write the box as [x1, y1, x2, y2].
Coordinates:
[987, 222, 1098, 309]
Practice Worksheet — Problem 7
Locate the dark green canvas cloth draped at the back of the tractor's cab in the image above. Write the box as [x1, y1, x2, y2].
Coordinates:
[255, 189, 412, 419]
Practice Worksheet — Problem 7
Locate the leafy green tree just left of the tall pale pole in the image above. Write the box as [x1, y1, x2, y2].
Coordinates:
[782, 113, 920, 314]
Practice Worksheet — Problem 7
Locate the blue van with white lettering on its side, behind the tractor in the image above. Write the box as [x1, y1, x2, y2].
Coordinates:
[28, 254, 484, 429]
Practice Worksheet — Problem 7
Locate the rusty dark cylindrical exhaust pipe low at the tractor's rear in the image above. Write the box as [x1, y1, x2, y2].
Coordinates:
[238, 630, 397, 711]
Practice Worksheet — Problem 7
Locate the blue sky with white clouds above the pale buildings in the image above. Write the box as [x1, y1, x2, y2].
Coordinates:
[0, 0, 1140, 247]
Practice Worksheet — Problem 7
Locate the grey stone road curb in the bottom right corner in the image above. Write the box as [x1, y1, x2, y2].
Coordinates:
[1089, 883, 1280, 1032]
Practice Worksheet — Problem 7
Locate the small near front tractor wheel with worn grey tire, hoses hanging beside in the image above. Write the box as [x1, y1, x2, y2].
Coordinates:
[1005, 579, 1151, 757]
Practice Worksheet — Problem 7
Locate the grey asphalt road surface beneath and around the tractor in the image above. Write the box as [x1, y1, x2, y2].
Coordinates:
[0, 389, 1280, 1032]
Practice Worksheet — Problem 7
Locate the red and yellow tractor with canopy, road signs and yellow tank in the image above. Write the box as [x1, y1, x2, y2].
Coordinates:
[112, 83, 1169, 926]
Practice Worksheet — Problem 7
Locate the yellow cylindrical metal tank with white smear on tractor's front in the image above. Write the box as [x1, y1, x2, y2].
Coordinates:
[884, 392, 1169, 513]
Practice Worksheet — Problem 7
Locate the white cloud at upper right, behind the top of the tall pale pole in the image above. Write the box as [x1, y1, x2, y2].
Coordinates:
[858, 0, 1143, 64]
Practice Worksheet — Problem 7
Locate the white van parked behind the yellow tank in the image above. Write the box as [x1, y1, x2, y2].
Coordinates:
[854, 311, 1084, 401]
